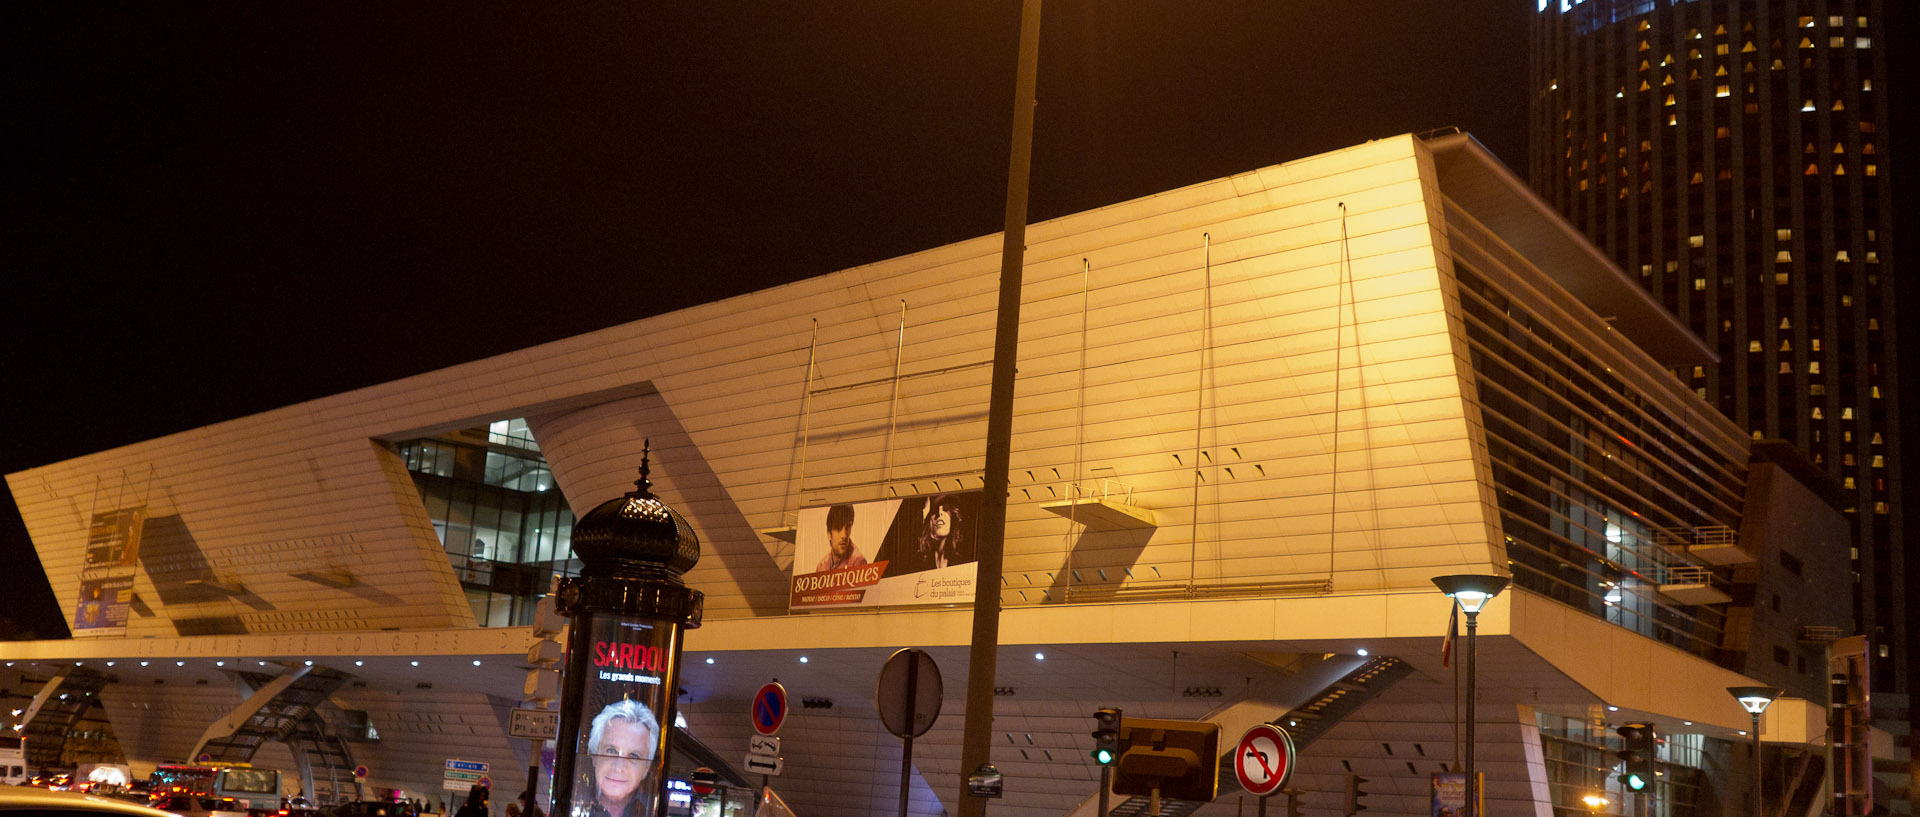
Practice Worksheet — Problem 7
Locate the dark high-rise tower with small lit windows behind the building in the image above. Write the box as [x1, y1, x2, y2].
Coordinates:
[1530, 0, 1914, 740]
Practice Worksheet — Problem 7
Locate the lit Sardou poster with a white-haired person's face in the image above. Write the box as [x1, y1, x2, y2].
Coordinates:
[568, 616, 680, 817]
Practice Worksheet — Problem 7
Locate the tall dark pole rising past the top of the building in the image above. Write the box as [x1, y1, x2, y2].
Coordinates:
[958, 0, 1041, 817]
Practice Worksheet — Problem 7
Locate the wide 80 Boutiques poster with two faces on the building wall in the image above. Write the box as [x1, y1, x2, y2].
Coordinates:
[787, 491, 981, 610]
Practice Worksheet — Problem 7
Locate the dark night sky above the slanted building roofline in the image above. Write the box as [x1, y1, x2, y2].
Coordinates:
[0, 0, 1914, 637]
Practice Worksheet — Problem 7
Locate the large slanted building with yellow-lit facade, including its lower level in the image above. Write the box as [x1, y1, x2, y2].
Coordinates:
[8, 134, 1853, 817]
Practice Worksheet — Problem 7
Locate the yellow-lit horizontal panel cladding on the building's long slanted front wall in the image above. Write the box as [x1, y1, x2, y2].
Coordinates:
[12, 138, 1697, 635]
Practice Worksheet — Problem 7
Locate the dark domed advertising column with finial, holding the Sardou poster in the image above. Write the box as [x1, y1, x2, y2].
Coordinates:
[551, 455, 703, 817]
